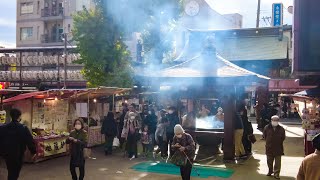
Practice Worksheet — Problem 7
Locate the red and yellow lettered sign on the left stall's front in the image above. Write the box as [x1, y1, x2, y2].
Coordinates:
[43, 138, 67, 157]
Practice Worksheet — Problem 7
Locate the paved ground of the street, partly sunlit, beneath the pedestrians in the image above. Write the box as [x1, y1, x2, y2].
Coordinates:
[0, 125, 304, 180]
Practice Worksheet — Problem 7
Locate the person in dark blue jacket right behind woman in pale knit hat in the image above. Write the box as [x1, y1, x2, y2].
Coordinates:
[166, 106, 180, 156]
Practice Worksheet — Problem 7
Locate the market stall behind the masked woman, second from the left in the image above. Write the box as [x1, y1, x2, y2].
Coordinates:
[70, 87, 130, 147]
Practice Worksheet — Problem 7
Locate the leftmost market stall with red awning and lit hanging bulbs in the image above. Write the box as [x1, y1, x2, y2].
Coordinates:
[4, 90, 83, 162]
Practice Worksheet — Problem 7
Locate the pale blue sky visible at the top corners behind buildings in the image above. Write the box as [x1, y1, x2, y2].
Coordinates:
[0, 0, 293, 47]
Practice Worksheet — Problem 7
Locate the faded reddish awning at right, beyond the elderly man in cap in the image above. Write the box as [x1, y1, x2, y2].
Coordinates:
[269, 79, 315, 93]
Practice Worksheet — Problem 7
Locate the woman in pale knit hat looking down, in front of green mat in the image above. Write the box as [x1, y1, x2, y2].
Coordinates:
[172, 124, 196, 180]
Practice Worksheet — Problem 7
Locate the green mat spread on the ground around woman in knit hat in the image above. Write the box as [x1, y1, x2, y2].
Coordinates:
[131, 162, 234, 178]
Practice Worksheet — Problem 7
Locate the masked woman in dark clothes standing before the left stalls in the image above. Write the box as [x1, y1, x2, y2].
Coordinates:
[66, 119, 88, 180]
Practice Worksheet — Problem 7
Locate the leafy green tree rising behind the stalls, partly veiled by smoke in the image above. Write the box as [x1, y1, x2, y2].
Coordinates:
[73, 5, 132, 87]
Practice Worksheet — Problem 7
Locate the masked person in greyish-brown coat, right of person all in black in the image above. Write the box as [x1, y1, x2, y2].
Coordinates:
[123, 105, 141, 158]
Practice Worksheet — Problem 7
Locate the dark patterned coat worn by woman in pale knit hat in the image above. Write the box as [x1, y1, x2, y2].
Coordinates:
[171, 133, 196, 161]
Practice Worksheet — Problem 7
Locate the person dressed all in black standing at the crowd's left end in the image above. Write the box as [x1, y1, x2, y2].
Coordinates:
[101, 112, 117, 155]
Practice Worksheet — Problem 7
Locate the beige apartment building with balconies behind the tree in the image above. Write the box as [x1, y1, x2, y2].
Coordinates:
[16, 0, 93, 47]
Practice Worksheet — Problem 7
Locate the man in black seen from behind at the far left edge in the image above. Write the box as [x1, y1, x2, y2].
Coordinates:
[0, 109, 36, 180]
